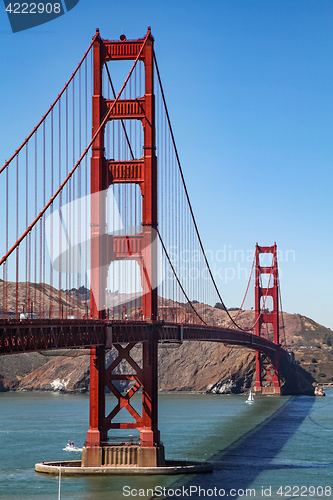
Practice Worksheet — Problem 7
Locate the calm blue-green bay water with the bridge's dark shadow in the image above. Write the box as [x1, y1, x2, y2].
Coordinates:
[0, 391, 333, 500]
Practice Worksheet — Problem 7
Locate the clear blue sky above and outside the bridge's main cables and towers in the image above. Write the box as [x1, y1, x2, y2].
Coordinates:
[0, 0, 333, 329]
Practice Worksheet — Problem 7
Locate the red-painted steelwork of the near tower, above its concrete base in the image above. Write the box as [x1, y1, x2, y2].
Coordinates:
[87, 30, 160, 452]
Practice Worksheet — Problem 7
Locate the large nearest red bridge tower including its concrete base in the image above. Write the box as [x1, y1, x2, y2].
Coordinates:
[82, 28, 164, 466]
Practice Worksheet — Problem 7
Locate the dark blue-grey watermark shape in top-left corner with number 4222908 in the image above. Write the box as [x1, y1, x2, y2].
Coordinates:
[4, 0, 79, 33]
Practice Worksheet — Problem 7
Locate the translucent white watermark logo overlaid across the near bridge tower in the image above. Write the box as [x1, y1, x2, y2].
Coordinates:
[45, 190, 164, 311]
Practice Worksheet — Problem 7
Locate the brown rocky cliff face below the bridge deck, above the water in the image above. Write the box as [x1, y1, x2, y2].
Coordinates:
[0, 328, 313, 394]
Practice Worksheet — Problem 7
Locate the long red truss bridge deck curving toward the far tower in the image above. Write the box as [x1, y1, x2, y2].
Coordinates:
[0, 319, 285, 355]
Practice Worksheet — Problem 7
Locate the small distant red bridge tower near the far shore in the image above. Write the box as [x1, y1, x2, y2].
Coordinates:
[254, 243, 281, 394]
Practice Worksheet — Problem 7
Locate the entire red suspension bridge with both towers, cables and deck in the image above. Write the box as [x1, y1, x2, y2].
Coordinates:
[0, 28, 287, 466]
